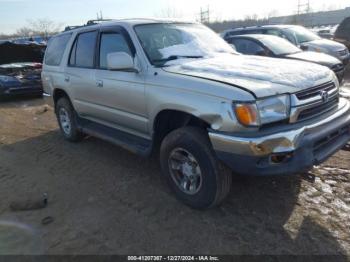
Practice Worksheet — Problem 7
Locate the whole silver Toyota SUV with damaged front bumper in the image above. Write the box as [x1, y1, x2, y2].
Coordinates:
[42, 20, 350, 208]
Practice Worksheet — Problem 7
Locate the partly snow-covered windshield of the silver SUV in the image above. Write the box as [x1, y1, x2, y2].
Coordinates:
[135, 23, 235, 66]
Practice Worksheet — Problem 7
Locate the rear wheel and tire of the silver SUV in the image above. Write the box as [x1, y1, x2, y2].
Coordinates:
[55, 97, 84, 142]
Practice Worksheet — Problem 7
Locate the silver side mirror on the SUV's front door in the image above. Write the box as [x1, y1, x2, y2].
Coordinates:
[107, 52, 138, 73]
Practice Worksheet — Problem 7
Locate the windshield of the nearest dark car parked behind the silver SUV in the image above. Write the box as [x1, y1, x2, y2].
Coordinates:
[259, 36, 301, 55]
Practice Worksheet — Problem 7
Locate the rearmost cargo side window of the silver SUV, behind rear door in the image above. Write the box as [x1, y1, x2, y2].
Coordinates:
[45, 34, 72, 66]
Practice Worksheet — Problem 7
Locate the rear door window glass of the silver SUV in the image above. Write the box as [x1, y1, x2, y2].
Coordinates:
[69, 31, 97, 68]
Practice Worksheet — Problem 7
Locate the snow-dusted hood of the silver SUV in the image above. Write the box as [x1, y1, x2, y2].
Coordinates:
[163, 54, 334, 97]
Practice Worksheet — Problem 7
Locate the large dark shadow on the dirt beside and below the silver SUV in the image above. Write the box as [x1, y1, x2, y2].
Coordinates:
[0, 131, 346, 256]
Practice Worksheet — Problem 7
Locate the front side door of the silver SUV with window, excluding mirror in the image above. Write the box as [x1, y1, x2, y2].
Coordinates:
[95, 27, 148, 135]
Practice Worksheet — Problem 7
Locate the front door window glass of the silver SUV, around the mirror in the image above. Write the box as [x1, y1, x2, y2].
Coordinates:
[100, 33, 132, 69]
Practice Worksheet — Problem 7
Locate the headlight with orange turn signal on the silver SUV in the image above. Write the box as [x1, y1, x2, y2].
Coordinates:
[234, 95, 290, 126]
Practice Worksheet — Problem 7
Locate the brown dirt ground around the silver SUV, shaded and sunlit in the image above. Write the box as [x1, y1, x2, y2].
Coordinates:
[0, 77, 350, 256]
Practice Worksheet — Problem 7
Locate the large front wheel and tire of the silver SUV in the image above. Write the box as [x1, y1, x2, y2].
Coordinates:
[160, 127, 232, 209]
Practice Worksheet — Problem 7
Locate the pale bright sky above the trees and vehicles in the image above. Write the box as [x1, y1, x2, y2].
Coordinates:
[0, 0, 350, 34]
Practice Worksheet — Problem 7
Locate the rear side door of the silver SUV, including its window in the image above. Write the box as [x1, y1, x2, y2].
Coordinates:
[65, 30, 99, 118]
